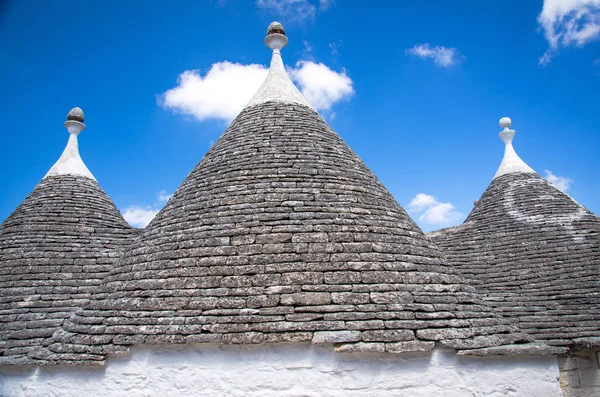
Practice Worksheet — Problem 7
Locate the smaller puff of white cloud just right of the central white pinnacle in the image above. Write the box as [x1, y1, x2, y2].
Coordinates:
[288, 61, 354, 110]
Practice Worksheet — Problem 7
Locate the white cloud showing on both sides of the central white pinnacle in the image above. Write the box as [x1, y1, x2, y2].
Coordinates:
[158, 61, 354, 122]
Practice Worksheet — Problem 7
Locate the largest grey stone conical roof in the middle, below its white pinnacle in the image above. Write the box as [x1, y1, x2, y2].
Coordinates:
[44, 102, 563, 362]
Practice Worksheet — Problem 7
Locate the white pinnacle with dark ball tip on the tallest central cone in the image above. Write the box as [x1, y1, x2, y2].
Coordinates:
[246, 22, 312, 108]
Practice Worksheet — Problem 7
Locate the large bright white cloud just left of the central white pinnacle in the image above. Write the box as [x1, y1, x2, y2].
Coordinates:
[159, 61, 268, 121]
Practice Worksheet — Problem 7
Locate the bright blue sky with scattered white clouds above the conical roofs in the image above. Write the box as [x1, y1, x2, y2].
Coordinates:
[0, 0, 600, 231]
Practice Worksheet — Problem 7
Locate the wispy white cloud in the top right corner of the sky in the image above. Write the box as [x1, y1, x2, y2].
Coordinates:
[538, 0, 600, 65]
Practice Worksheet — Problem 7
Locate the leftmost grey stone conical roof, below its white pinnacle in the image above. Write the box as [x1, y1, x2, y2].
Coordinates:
[0, 175, 135, 365]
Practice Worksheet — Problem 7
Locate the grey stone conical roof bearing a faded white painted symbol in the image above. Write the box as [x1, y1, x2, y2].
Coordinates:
[429, 173, 600, 346]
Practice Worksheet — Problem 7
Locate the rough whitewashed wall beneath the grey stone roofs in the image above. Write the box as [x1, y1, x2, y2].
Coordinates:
[0, 344, 562, 397]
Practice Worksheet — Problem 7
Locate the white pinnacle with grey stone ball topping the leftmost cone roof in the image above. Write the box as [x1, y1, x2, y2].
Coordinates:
[44, 107, 96, 180]
